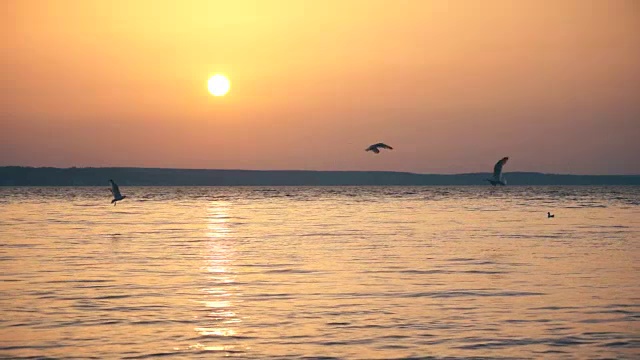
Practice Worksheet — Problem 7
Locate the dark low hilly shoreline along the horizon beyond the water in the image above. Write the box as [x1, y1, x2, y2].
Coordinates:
[0, 166, 640, 186]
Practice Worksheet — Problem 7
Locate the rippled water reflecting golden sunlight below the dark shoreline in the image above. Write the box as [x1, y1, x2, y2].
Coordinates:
[0, 186, 640, 359]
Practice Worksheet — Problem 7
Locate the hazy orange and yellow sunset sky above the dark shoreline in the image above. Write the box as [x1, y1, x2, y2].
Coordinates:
[0, 0, 640, 174]
